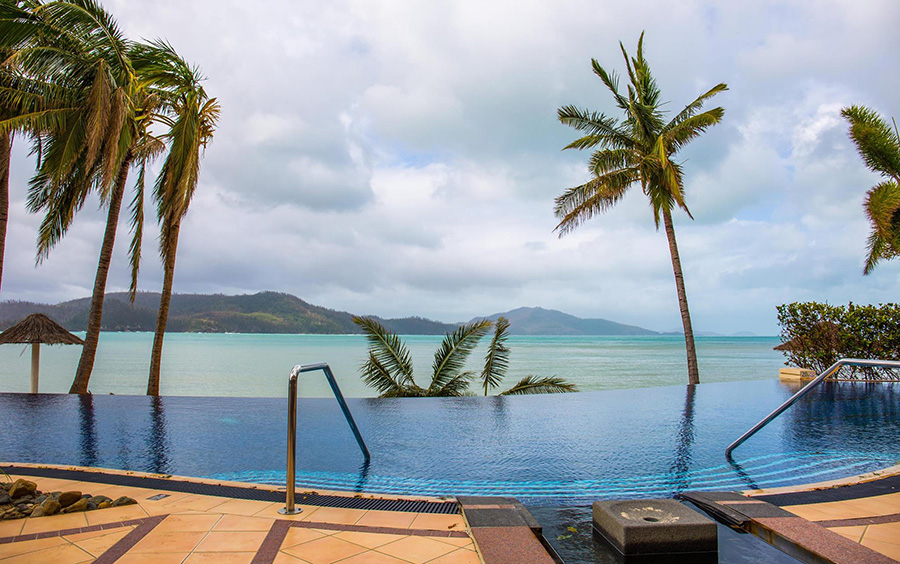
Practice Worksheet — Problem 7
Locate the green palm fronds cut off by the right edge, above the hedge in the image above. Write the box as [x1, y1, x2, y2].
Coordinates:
[841, 106, 900, 274]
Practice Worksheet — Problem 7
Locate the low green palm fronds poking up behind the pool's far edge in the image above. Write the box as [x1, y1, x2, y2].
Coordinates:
[353, 317, 577, 398]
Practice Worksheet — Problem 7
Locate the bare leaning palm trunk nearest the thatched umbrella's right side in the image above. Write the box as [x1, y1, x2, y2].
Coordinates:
[69, 152, 134, 394]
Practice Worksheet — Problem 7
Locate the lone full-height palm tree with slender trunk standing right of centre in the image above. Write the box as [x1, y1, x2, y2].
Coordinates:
[555, 33, 728, 384]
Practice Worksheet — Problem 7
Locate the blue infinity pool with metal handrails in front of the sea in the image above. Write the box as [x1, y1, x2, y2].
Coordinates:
[0, 381, 900, 507]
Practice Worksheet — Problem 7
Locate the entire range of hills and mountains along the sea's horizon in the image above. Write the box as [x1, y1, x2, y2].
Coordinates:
[0, 292, 660, 335]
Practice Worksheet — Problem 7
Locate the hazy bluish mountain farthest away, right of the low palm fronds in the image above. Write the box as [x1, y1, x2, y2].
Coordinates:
[474, 307, 659, 335]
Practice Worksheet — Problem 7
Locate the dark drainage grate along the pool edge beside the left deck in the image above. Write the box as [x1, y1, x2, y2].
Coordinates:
[3, 466, 459, 515]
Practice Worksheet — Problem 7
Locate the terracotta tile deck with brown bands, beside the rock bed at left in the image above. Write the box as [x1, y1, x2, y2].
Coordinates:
[0, 475, 480, 564]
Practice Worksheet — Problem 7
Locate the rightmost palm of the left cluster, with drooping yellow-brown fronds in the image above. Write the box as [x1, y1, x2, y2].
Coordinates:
[133, 41, 219, 396]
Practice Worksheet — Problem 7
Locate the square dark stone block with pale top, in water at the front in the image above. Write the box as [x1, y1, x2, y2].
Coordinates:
[594, 499, 718, 555]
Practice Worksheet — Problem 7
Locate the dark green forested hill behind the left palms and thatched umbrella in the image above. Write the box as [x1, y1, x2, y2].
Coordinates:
[0, 292, 456, 335]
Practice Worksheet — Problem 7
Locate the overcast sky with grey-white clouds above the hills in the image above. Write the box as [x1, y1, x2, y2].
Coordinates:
[0, 0, 900, 334]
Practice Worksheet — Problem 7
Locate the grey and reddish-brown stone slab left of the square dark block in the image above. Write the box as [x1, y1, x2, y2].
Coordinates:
[456, 496, 564, 564]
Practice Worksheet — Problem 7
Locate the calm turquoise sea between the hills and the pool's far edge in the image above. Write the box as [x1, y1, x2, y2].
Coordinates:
[0, 333, 784, 397]
